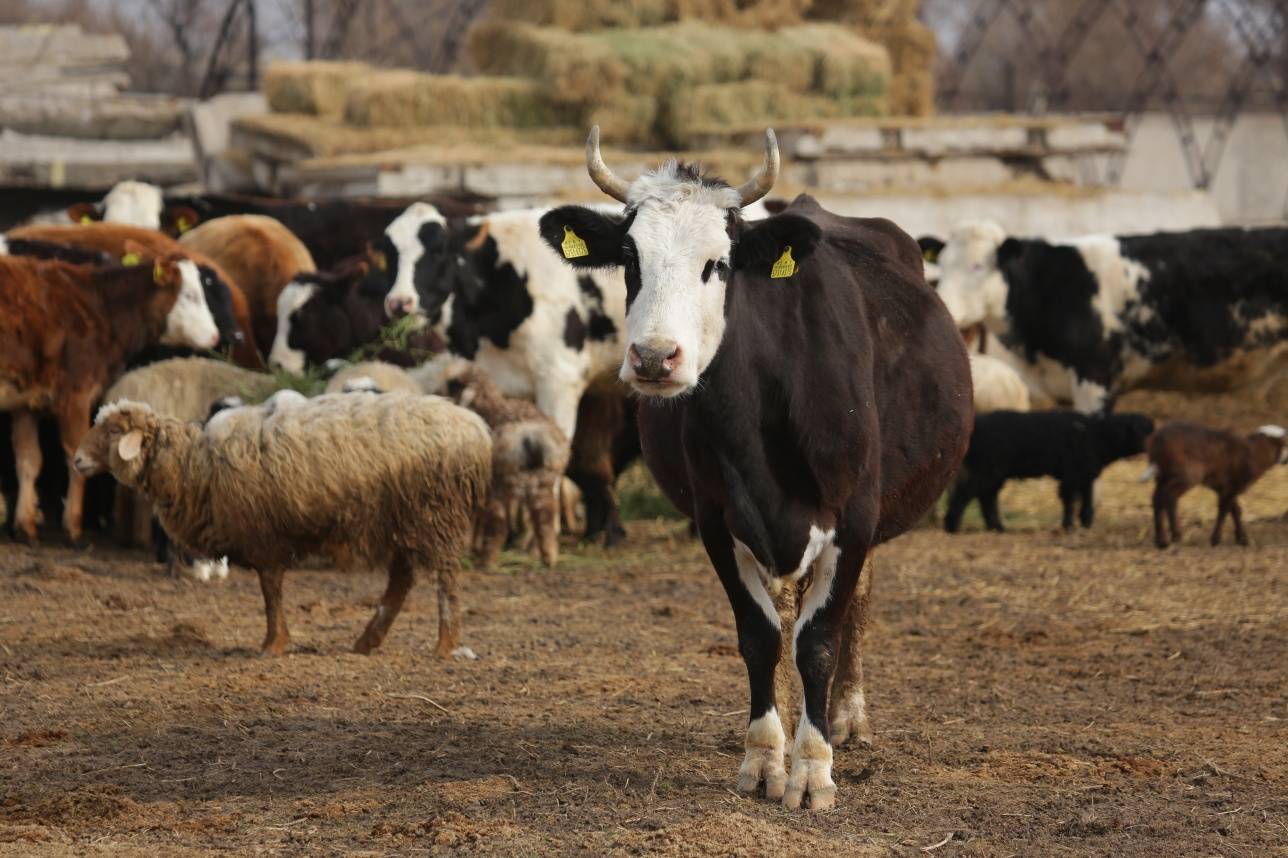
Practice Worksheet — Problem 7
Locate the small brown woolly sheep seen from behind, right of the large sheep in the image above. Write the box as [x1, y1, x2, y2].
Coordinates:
[443, 361, 569, 568]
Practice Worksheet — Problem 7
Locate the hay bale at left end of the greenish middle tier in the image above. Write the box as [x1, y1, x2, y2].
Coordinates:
[466, 21, 626, 107]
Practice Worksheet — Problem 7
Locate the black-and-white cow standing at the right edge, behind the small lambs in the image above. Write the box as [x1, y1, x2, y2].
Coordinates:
[938, 222, 1288, 412]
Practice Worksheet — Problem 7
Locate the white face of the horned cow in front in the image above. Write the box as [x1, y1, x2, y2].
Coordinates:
[620, 164, 739, 397]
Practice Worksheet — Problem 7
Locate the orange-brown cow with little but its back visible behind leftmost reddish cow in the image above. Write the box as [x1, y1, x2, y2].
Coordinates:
[5, 223, 264, 370]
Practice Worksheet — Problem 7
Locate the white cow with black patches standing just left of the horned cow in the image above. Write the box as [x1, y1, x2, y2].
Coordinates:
[371, 202, 626, 438]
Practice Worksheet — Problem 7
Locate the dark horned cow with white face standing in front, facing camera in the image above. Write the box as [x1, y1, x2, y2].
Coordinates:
[541, 126, 972, 809]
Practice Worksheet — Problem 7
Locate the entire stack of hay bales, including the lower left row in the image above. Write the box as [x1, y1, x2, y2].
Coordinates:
[251, 0, 933, 156]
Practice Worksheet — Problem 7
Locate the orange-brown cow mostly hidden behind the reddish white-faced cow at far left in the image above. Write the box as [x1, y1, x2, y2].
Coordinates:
[5, 222, 267, 370]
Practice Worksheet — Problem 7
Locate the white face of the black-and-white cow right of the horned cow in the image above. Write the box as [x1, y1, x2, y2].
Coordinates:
[936, 220, 1006, 327]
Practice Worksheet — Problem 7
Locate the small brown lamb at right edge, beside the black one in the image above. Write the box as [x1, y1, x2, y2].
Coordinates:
[1142, 421, 1288, 548]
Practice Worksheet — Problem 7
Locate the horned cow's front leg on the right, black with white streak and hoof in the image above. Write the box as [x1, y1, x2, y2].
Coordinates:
[783, 541, 866, 810]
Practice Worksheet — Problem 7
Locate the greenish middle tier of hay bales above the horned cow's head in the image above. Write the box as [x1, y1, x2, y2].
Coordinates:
[468, 21, 890, 147]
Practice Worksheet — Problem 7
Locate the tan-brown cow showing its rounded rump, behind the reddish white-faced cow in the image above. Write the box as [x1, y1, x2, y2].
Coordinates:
[179, 215, 317, 354]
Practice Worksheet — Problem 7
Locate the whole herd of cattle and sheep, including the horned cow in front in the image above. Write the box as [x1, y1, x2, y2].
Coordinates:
[0, 128, 1288, 809]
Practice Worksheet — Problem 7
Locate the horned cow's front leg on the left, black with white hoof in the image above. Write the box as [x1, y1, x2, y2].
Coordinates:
[698, 514, 787, 800]
